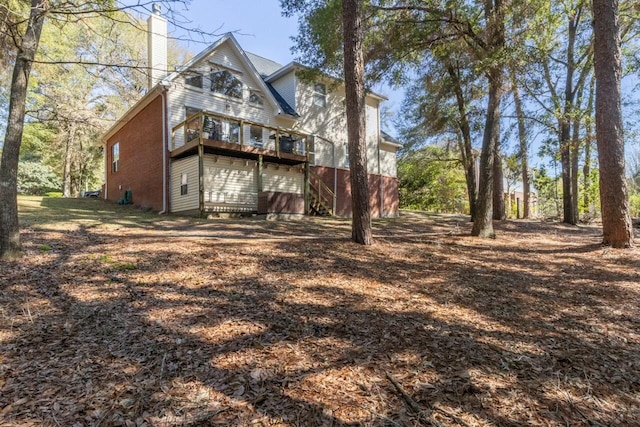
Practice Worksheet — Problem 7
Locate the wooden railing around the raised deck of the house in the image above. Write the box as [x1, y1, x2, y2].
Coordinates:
[171, 111, 308, 156]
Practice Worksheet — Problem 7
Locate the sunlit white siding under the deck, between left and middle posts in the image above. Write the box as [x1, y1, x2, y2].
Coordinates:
[204, 155, 258, 209]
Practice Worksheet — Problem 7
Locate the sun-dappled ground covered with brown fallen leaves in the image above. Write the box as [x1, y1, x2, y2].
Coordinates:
[0, 198, 640, 426]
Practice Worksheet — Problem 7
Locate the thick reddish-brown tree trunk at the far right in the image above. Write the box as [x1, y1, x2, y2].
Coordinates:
[593, 0, 633, 248]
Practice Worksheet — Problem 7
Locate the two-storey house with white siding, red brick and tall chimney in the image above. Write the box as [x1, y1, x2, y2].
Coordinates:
[102, 7, 400, 221]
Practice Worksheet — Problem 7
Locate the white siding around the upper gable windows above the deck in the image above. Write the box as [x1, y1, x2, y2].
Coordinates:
[169, 42, 276, 147]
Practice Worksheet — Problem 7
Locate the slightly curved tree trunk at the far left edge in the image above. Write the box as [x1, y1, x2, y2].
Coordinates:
[0, 0, 48, 258]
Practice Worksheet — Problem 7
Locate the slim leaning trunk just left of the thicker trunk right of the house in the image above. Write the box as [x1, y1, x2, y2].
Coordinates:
[447, 65, 478, 222]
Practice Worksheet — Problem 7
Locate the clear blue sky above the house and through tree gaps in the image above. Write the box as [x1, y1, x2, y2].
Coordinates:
[156, 0, 403, 136]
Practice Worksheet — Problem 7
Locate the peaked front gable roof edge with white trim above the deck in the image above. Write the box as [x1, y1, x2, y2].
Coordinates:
[160, 33, 300, 118]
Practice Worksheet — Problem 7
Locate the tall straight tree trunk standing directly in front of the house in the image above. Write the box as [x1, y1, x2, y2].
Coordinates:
[342, 0, 373, 245]
